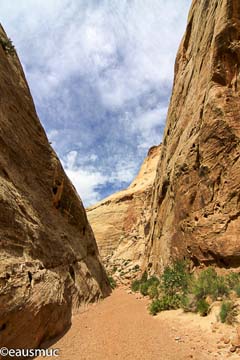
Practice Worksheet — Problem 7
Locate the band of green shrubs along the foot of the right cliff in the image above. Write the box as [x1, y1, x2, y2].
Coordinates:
[131, 261, 240, 324]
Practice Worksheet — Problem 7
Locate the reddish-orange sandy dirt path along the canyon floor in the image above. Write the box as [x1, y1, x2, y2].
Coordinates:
[39, 289, 239, 360]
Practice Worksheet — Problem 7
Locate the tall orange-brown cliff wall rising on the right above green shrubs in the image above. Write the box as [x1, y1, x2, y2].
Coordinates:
[144, 0, 240, 271]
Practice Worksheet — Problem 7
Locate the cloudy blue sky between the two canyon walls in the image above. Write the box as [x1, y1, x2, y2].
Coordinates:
[0, 0, 191, 206]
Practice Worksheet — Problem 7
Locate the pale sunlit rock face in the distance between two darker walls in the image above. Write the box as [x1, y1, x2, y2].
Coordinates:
[87, 146, 160, 261]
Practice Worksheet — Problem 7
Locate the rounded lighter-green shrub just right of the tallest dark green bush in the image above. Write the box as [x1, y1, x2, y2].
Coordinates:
[193, 268, 229, 300]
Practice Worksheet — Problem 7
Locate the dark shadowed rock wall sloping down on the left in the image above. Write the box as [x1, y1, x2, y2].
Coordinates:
[0, 28, 109, 348]
